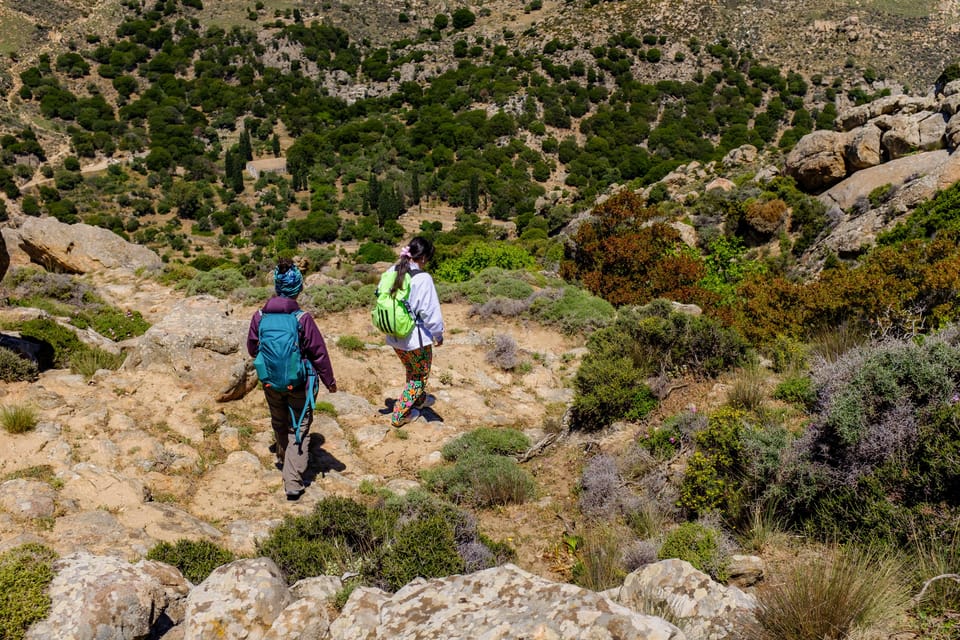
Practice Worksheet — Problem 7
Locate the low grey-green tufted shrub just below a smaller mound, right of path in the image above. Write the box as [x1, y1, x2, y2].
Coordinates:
[423, 454, 536, 507]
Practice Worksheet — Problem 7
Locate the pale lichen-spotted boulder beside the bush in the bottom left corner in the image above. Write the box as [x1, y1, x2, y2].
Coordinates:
[26, 553, 190, 640]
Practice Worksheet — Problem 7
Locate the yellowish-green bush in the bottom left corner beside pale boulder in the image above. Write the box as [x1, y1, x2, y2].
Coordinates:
[0, 543, 57, 640]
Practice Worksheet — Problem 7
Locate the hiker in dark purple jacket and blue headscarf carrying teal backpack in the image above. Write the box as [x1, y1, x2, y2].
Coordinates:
[247, 258, 337, 500]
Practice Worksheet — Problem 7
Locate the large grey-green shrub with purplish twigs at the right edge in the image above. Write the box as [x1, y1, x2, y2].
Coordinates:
[770, 328, 960, 544]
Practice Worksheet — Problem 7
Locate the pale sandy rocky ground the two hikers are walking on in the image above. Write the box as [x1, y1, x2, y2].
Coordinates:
[0, 262, 608, 575]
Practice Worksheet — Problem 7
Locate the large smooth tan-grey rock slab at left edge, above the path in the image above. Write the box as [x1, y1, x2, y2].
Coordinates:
[17, 217, 162, 273]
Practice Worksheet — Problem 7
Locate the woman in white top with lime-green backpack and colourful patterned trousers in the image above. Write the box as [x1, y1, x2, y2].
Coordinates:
[371, 236, 443, 427]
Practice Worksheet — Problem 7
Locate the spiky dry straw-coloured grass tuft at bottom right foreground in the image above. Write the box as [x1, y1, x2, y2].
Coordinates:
[746, 547, 909, 640]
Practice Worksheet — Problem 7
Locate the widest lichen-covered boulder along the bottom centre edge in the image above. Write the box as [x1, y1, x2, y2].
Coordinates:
[330, 564, 685, 640]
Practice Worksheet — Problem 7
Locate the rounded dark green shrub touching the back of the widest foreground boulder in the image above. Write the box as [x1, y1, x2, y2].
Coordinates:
[380, 515, 464, 591]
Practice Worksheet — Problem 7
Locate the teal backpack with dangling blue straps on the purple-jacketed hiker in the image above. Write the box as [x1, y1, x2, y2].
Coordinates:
[253, 310, 317, 444]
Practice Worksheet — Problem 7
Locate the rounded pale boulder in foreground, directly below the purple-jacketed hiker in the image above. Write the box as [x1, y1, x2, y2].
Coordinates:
[183, 558, 293, 640]
